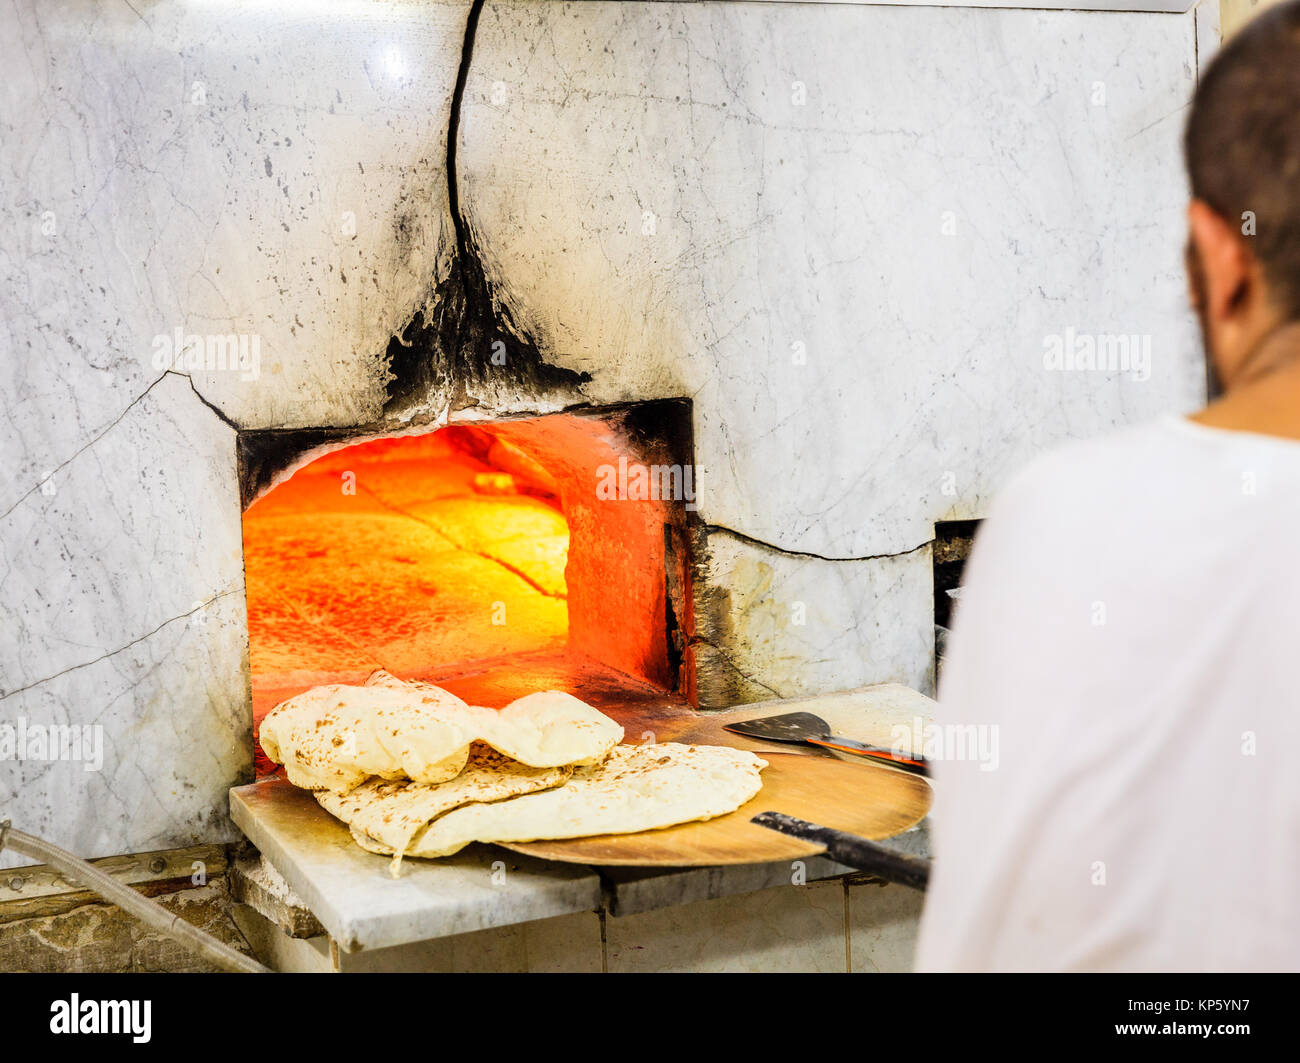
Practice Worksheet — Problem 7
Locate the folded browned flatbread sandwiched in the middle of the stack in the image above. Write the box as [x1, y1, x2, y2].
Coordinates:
[316, 742, 573, 871]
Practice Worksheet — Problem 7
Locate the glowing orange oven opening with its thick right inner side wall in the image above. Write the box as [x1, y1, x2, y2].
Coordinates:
[242, 402, 694, 775]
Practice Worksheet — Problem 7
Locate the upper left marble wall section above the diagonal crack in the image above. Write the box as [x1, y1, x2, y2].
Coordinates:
[0, 0, 469, 454]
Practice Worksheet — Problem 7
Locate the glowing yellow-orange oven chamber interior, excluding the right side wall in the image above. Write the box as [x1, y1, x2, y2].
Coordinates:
[244, 429, 569, 764]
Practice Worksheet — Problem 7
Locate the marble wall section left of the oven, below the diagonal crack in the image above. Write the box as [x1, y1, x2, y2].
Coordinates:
[0, 377, 252, 865]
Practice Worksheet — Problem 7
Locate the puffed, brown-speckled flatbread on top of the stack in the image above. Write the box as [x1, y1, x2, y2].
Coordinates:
[259, 672, 623, 793]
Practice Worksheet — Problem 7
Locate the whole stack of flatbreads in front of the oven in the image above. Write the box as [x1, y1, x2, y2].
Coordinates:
[259, 672, 767, 873]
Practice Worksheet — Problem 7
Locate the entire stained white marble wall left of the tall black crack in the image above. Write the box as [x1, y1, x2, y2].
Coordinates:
[0, 1, 468, 864]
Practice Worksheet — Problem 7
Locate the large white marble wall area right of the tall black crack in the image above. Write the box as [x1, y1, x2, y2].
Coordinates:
[459, 3, 1203, 557]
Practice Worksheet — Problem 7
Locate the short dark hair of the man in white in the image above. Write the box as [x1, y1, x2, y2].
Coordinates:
[1183, 0, 1300, 318]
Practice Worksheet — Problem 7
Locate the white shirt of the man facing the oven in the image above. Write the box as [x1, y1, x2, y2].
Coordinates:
[917, 417, 1300, 971]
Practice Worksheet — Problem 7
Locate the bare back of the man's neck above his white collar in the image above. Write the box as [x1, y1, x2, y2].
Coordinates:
[1191, 321, 1300, 439]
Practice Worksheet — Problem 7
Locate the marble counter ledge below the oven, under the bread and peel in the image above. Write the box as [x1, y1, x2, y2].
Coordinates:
[230, 685, 933, 953]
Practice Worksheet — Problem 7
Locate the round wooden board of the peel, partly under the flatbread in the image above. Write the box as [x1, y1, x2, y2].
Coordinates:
[502, 752, 931, 867]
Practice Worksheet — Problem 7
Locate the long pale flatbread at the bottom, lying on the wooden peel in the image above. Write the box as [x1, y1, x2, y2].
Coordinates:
[352, 742, 767, 856]
